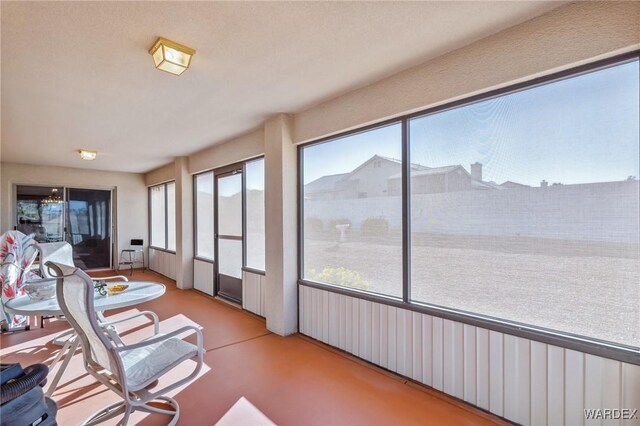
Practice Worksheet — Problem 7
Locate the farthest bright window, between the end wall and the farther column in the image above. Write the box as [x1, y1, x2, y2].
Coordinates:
[149, 182, 176, 251]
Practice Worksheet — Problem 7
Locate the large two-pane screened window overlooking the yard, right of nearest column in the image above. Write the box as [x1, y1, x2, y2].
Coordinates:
[299, 55, 640, 350]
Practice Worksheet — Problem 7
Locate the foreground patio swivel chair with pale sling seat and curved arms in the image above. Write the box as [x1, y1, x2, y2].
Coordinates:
[47, 262, 204, 425]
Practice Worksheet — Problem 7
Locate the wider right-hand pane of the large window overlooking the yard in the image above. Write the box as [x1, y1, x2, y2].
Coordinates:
[409, 61, 640, 346]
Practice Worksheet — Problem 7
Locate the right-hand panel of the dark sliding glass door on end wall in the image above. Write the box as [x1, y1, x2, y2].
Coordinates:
[66, 188, 112, 269]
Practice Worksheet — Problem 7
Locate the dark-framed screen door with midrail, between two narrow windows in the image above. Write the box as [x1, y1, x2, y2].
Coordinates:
[215, 169, 243, 303]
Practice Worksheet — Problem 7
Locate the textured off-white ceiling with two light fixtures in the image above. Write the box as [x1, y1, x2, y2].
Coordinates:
[0, 1, 563, 172]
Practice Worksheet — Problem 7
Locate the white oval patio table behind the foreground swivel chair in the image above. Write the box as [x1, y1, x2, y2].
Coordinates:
[4, 278, 166, 396]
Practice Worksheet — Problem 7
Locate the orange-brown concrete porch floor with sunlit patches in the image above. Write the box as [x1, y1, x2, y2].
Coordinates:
[0, 271, 504, 426]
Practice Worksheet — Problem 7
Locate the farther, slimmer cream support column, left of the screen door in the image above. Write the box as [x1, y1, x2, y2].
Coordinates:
[174, 157, 193, 289]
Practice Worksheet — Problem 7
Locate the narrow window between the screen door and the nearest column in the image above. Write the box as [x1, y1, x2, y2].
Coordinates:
[244, 158, 265, 271]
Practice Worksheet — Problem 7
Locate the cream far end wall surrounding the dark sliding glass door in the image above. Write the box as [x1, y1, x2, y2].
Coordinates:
[0, 163, 149, 263]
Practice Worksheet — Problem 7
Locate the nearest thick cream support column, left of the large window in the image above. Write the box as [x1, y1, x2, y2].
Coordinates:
[264, 114, 298, 336]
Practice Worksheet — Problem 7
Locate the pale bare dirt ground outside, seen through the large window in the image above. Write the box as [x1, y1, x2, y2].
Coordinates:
[304, 237, 640, 346]
